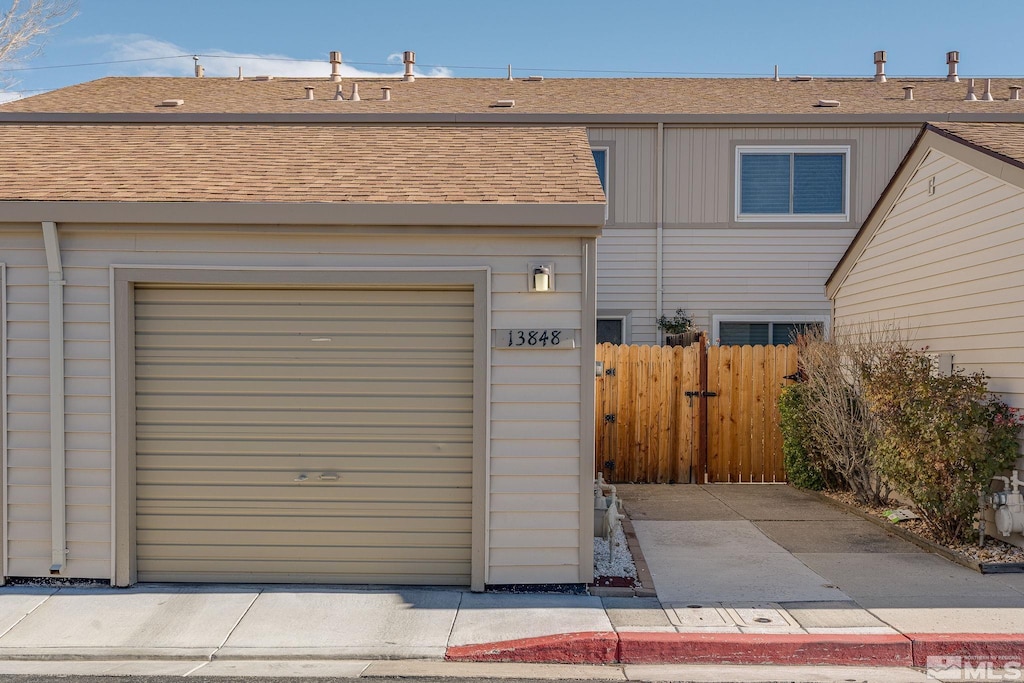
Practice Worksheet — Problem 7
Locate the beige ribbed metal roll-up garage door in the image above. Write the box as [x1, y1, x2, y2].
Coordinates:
[135, 287, 473, 585]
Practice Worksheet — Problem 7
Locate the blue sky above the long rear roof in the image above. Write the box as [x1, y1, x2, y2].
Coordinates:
[6, 0, 1024, 100]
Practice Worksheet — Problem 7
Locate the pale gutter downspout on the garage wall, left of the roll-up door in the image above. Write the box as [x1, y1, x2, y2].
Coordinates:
[43, 221, 68, 573]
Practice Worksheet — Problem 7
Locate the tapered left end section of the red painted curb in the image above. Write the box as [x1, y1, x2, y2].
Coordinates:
[444, 631, 618, 664]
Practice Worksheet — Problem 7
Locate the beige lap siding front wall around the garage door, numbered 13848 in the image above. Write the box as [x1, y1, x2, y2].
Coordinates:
[0, 225, 583, 584]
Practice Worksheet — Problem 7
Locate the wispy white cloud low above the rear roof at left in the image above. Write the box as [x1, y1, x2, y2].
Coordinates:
[82, 34, 453, 78]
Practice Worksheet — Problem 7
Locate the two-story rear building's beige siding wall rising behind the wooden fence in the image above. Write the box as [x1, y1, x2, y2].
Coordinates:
[589, 125, 921, 344]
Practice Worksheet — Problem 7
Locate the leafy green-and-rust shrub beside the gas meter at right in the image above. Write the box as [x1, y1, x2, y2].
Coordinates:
[864, 348, 1021, 544]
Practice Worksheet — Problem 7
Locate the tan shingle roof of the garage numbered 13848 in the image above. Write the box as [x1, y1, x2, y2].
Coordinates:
[0, 124, 604, 204]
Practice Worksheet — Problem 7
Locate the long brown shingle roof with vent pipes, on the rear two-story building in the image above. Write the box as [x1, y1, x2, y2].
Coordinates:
[6, 77, 1024, 117]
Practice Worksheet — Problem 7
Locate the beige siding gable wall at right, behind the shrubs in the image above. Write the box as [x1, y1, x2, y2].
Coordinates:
[836, 150, 1024, 408]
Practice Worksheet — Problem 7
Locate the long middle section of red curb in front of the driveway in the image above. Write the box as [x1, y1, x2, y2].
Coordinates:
[618, 633, 913, 667]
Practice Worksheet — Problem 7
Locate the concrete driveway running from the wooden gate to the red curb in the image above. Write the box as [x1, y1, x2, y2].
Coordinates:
[616, 484, 1024, 634]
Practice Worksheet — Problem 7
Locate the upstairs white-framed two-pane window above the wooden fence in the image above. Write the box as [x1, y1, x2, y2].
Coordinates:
[736, 145, 850, 222]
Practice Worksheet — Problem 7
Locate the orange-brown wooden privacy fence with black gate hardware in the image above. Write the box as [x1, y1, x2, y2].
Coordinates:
[595, 341, 797, 483]
